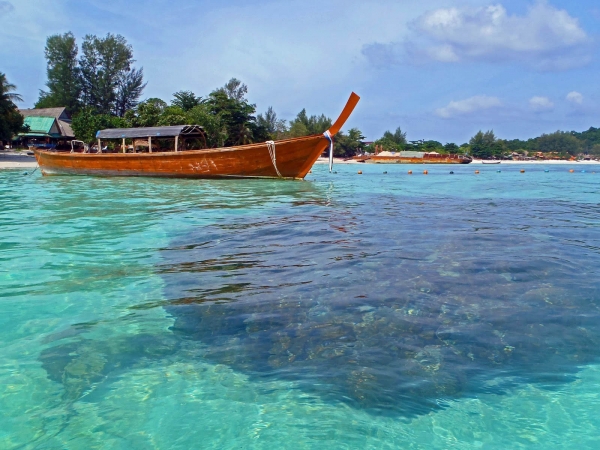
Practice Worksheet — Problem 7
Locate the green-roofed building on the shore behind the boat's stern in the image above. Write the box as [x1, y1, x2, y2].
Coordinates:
[14, 108, 75, 149]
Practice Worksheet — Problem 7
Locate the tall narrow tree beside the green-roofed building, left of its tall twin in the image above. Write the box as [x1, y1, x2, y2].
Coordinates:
[35, 32, 81, 114]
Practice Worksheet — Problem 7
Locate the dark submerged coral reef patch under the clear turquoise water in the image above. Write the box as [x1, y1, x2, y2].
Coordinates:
[42, 195, 600, 416]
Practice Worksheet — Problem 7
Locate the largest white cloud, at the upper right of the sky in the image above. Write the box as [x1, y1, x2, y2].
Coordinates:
[363, 1, 591, 70]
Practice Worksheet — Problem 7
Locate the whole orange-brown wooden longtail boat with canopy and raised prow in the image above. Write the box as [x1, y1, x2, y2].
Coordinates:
[34, 92, 360, 179]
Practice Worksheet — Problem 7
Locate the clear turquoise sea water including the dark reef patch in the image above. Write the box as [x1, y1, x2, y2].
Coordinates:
[0, 165, 600, 448]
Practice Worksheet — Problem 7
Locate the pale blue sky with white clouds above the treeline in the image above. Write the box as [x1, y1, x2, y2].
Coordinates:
[0, 0, 600, 144]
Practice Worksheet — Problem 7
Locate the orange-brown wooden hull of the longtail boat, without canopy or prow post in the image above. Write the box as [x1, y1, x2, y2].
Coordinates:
[34, 135, 329, 179]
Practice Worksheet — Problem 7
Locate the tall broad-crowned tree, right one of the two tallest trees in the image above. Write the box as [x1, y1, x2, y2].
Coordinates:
[79, 33, 145, 115]
